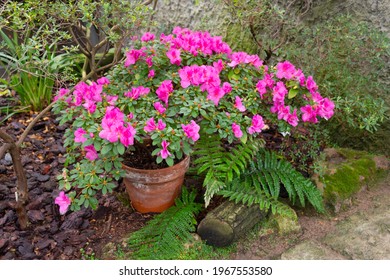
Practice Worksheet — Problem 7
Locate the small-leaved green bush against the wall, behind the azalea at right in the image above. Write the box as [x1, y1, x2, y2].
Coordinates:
[215, 0, 390, 153]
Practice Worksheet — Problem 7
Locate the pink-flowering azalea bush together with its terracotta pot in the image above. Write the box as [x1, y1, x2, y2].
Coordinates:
[54, 27, 334, 213]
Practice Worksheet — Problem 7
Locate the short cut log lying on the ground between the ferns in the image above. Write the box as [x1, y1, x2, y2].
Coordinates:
[198, 201, 268, 247]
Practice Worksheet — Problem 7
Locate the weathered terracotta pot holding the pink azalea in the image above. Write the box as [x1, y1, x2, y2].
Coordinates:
[123, 156, 190, 213]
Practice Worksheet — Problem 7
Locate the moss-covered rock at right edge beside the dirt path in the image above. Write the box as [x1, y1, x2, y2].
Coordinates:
[314, 148, 389, 212]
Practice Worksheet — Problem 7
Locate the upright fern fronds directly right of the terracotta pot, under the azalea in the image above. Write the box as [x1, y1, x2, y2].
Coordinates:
[193, 134, 264, 207]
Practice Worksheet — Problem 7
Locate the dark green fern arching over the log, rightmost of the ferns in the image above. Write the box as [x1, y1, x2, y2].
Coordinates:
[219, 150, 324, 215]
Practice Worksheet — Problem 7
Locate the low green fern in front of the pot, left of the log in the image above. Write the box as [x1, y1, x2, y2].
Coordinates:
[129, 188, 201, 260]
